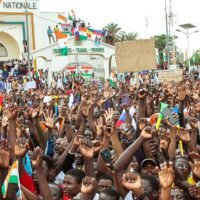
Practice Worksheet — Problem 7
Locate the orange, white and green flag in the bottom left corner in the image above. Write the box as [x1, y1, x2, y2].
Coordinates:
[1, 160, 22, 199]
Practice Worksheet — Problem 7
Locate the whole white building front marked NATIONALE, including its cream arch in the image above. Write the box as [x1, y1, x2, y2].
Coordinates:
[0, 0, 62, 61]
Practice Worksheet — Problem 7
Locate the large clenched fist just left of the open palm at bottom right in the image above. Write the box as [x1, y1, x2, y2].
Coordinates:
[122, 172, 142, 191]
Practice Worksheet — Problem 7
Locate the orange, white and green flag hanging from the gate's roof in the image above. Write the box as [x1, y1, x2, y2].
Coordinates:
[56, 31, 68, 56]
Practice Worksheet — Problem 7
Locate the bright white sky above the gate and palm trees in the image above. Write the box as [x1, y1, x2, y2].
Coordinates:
[40, 0, 200, 53]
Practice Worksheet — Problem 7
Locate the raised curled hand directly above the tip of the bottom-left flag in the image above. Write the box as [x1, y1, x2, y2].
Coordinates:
[15, 137, 29, 157]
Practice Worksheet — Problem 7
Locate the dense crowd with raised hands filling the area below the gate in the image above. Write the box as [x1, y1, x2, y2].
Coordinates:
[0, 61, 200, 200]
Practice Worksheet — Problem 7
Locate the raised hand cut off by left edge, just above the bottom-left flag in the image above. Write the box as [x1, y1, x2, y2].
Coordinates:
[0, 140, 10, 168]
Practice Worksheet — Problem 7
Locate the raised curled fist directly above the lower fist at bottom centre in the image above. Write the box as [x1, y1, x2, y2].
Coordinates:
[79, 138, 94, 160]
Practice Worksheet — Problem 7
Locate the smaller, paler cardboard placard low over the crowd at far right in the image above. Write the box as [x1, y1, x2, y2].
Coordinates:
[158, 69, 183, 83]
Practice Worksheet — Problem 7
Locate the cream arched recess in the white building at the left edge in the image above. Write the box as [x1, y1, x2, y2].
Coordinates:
[0, 32, 21, 61]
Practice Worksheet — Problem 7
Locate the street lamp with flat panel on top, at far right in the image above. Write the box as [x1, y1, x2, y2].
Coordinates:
[176, 24, 199, 68]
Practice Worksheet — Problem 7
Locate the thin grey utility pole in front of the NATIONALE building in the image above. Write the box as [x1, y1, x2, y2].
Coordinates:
[25, 0, 32, 81]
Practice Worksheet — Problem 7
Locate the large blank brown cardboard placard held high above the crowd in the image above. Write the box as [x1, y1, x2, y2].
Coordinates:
[115, 39, 157, 73]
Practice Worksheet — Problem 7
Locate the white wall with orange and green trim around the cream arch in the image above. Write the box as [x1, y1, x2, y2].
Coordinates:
[0, 0, 63, 60]
